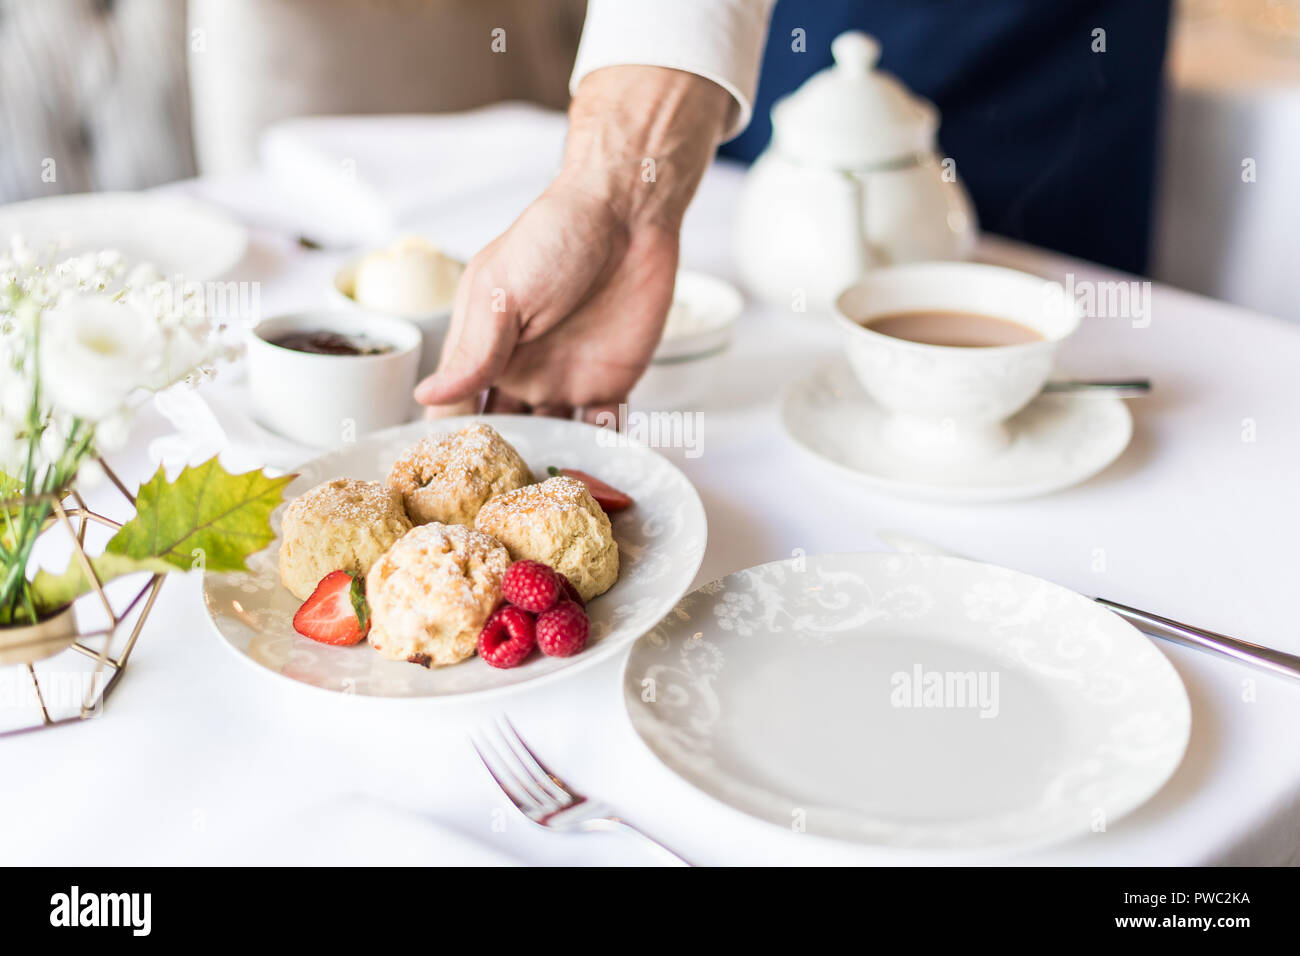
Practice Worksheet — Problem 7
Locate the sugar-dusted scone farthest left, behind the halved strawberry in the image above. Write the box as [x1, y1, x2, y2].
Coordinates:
[280, 479, 411, 601]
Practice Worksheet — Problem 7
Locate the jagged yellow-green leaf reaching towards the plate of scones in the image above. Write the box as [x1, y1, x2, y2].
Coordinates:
[31, 458, 296, 611]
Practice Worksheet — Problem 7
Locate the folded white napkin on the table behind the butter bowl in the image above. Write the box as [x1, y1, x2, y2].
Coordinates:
[259, 103, 566, 252]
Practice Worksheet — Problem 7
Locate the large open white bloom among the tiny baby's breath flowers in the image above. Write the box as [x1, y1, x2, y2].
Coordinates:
[40, 295, 160, 421]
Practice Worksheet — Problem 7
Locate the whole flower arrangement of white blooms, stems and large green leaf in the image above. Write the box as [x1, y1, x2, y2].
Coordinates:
[0, 239, 293, 642]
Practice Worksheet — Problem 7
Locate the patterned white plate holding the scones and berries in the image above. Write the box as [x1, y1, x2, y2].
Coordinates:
[203, 415, 707, 698]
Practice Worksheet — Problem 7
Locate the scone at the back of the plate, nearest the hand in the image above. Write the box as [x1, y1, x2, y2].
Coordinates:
[389, 423, 533, 527]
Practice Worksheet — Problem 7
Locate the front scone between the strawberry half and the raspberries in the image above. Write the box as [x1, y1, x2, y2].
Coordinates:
[365, 522, 510, 667]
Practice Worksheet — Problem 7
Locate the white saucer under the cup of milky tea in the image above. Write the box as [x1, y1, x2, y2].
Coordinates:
[781, 359, 1132, 502]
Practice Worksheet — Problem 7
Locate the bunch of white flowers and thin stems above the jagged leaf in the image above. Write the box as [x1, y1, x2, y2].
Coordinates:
[0, 237, 226, 626]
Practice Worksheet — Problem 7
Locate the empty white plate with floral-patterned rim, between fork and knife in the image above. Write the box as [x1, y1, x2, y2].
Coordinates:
[624, 554, 1191, 848]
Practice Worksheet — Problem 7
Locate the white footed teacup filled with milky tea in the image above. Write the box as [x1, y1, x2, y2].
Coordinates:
[835, 261, 1079, 462]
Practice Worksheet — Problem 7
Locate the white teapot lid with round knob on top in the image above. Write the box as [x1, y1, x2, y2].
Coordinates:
[772, 31, 939, 168]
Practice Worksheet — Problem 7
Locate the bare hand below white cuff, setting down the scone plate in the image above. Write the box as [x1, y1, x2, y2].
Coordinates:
[416, 66, 733, 421]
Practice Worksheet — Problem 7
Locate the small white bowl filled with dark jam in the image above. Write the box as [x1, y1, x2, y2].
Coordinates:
[247, 311, 423, 447]
